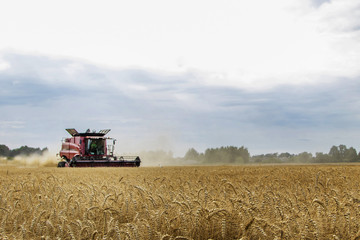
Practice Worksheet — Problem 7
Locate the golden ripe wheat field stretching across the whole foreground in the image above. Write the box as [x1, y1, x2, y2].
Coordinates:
[0, 165, 360, 239]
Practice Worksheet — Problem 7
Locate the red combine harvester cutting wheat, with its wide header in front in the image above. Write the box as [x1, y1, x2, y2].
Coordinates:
[58, 128, 141, 167]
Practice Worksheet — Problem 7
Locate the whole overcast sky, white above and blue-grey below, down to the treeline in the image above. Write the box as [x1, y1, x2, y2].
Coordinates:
[0, 0, 360, 156]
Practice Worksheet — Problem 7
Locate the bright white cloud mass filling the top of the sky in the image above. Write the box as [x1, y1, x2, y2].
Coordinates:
[0, 0, 360, 90]
